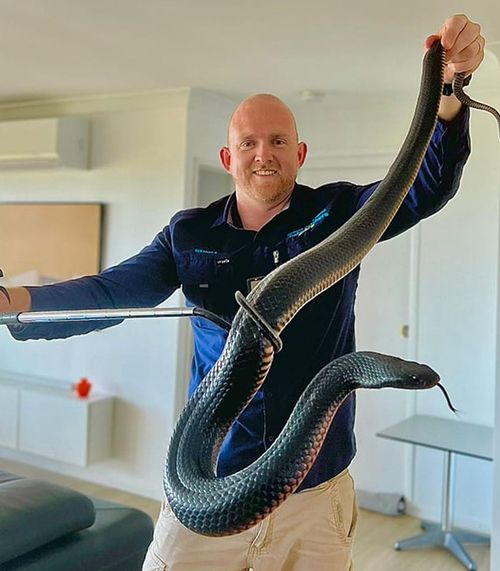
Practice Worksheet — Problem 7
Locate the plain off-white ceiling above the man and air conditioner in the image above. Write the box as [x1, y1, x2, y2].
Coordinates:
[0, 0, 500, 104]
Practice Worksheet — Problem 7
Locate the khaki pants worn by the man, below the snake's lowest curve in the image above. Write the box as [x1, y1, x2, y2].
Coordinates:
[143, 470, 358, 571]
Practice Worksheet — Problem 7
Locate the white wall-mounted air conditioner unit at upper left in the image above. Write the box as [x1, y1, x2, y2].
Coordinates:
[0, 117, 89, 169]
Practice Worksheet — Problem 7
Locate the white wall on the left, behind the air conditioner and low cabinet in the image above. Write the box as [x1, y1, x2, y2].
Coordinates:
[0, 90, 189, 498]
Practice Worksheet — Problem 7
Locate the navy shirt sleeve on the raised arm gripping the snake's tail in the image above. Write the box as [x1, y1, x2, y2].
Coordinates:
[356, 106, 470, 240]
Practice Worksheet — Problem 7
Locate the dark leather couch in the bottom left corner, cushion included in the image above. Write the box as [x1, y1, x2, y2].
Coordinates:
[0, 470, 153, 571]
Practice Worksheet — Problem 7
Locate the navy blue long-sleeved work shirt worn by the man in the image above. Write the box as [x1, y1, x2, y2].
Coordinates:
[11, 110, 470, 489]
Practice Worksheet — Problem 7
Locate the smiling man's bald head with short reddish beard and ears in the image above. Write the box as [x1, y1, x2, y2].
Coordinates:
[220, 95, 307, 205]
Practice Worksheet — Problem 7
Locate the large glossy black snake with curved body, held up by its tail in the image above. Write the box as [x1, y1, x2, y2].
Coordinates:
[164, 42, 498, 536]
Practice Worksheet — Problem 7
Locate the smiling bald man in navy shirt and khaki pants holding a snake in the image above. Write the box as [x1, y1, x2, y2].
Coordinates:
[0, 15, 484, 571]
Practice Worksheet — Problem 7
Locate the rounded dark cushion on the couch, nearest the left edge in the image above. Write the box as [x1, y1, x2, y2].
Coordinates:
[0, 473, 95, 564]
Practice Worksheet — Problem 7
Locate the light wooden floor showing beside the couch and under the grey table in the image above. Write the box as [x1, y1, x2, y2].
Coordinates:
[0, 459, 490, 571]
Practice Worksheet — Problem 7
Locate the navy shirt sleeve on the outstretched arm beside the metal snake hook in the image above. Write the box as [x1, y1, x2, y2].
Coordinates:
[9, 226, 179, 341]
